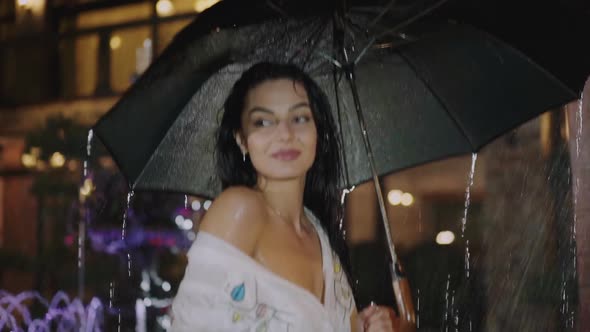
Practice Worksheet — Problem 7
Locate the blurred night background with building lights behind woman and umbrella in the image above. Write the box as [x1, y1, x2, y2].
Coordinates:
[0, 0, 590, 331]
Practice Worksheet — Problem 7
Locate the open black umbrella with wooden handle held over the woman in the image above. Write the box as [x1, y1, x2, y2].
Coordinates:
[96, 0, 576, 320]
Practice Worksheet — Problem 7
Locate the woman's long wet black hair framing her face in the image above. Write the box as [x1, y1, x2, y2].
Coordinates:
[216, 62, 354, 287]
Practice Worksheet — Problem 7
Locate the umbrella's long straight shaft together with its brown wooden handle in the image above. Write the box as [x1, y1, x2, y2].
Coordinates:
[344, 63, 416, 331]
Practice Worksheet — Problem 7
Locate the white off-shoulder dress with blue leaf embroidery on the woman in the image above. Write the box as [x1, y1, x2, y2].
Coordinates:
[171, 209, 354, 332]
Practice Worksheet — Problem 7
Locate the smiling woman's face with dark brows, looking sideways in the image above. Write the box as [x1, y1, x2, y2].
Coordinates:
[236, 79, 317, 180]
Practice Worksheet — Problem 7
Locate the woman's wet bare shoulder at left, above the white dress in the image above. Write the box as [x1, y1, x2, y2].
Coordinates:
[199, 186, 268, 256]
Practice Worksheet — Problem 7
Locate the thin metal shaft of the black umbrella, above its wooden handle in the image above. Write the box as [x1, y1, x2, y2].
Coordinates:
[346, 66, 397, 266]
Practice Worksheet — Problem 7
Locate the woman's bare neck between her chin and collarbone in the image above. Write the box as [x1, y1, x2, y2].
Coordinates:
[257, 176, 305, 232]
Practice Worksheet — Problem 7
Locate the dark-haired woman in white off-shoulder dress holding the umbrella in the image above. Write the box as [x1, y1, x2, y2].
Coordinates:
[172, 63, 398, 332]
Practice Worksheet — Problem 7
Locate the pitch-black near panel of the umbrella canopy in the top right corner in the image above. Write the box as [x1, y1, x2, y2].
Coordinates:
[429, 0, 590, 96]
